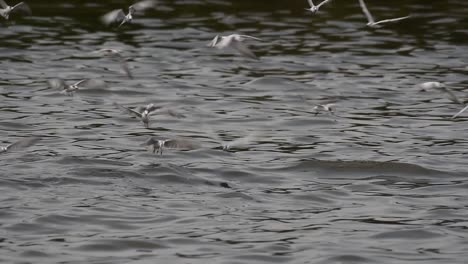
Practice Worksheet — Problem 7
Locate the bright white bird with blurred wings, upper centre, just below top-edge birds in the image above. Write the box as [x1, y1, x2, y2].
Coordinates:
[208, 34, 261, 60]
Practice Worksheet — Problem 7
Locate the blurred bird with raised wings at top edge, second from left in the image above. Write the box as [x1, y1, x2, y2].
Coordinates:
[101, 0, 156, 27]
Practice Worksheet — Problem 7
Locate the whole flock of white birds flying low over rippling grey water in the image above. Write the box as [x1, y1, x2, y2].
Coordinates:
[0, 0, 468, 154]
